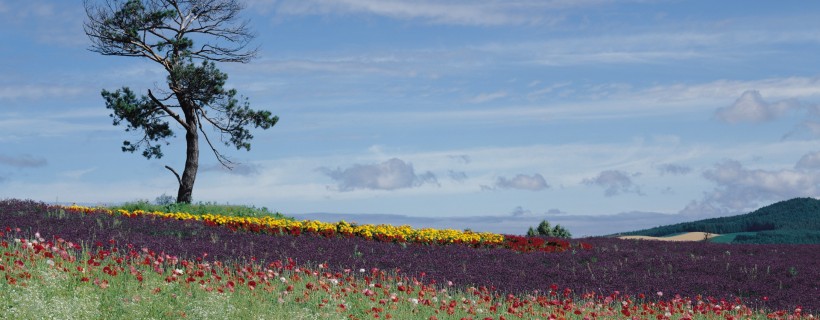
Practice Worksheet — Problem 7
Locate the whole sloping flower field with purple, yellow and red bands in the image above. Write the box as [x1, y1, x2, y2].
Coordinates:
[0, 200, 820, 319]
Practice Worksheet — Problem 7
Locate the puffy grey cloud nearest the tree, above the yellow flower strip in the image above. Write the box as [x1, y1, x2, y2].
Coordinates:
[318, 158, 438, 191]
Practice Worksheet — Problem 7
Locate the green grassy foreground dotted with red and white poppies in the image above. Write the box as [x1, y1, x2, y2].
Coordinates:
[0, 230, 801, 319]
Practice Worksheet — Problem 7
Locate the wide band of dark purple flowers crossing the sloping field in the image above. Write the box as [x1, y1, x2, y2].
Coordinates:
[0, 200, 820, 312]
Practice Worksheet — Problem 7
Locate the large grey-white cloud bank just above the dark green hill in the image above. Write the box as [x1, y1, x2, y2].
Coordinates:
[681, 159, 820, 216]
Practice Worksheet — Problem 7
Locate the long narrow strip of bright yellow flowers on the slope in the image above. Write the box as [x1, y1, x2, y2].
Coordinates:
[59, 205, 504, 245]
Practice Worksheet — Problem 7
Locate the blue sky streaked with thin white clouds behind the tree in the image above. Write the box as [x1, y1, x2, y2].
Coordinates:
[0, 0, 820, 235]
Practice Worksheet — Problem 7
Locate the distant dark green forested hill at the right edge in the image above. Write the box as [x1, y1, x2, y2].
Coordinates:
[620, 198, 820, 244]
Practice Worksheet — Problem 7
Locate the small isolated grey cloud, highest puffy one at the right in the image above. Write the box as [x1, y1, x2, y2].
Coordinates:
[715, 90, 800, 123]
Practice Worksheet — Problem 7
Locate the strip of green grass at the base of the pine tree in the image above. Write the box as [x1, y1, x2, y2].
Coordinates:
[106, 200, 293, 219]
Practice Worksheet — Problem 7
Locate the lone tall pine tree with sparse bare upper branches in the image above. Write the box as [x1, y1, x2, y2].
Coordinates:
[84, 0, 279, 203]
